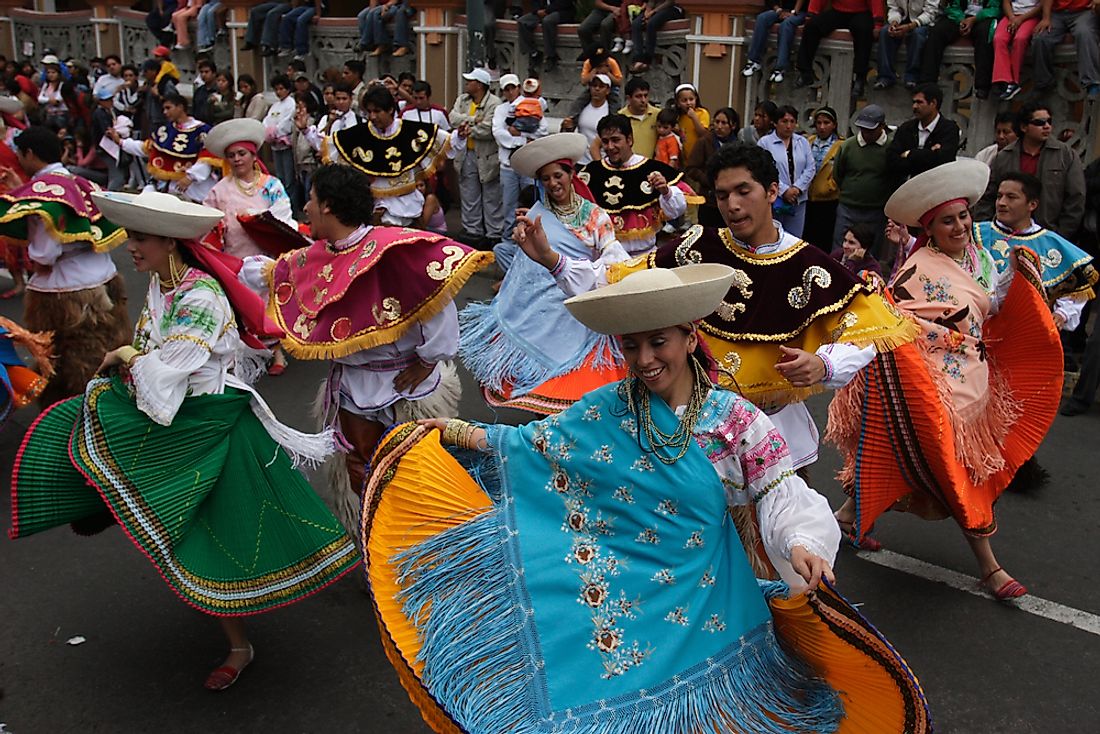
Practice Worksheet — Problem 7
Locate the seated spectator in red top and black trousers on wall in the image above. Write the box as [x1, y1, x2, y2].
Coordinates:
[795, 0, 884, 97]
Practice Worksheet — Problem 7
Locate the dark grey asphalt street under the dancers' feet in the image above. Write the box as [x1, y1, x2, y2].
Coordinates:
[0, 249, 1100, 734]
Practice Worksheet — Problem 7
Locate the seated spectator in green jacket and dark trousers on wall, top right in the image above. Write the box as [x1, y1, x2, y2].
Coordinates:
[921, 0, 1002, 99]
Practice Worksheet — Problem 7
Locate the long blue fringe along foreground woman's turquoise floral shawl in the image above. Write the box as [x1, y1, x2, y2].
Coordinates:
[393, 512, 844, 734]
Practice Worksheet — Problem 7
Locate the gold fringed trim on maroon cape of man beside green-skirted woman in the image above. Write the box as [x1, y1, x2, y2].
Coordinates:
[275, 252, 494, 360]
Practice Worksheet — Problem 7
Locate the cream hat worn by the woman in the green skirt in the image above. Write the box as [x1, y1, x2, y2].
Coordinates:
[91, 191, 226, 240]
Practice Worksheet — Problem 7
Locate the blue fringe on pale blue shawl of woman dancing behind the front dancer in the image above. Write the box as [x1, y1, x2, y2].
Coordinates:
[459, 303, 623, 396]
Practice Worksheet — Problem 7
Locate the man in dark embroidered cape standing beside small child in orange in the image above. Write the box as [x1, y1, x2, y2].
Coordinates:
[578, 114, 695, 256]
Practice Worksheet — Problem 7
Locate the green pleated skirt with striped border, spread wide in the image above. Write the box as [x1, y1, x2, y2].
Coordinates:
[9, 379, 359, 616]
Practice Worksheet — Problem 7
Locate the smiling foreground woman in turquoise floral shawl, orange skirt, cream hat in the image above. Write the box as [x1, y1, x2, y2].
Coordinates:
[360, 264, 931, 734]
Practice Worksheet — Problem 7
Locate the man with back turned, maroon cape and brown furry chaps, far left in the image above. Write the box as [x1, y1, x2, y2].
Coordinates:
[0, 125, 130, 406]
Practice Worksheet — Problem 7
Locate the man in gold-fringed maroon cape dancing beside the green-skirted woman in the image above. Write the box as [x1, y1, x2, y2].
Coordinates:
[241, 165, 493, 528]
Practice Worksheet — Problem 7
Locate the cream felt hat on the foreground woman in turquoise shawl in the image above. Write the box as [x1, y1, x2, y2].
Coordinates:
[565, 263, 736, 335]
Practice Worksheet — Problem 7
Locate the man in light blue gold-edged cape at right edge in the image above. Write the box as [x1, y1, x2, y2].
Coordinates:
[974, 172, 1100, 331]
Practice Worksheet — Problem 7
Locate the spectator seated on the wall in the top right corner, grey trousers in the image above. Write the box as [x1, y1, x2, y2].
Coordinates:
[1034, 0, 1100, 99]
